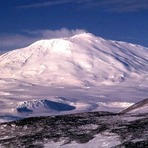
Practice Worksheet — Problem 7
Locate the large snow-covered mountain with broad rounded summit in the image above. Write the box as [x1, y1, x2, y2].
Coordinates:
[0, 33, 148, 86]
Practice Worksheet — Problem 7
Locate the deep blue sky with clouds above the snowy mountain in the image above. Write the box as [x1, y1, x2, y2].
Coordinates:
[0, 0, 148, 53]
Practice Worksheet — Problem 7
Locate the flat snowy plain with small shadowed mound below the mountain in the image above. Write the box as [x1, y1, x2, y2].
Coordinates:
[0, 83, 147, 121]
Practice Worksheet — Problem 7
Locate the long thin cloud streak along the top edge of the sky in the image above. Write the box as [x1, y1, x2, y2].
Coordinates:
[18, 0, 148, 12]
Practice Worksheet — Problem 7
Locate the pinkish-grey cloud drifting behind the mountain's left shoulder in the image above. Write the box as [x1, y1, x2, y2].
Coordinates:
[0, 28, 86, 52]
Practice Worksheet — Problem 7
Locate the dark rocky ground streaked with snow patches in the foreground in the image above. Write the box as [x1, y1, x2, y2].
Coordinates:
[0, 112, 148, 148]
